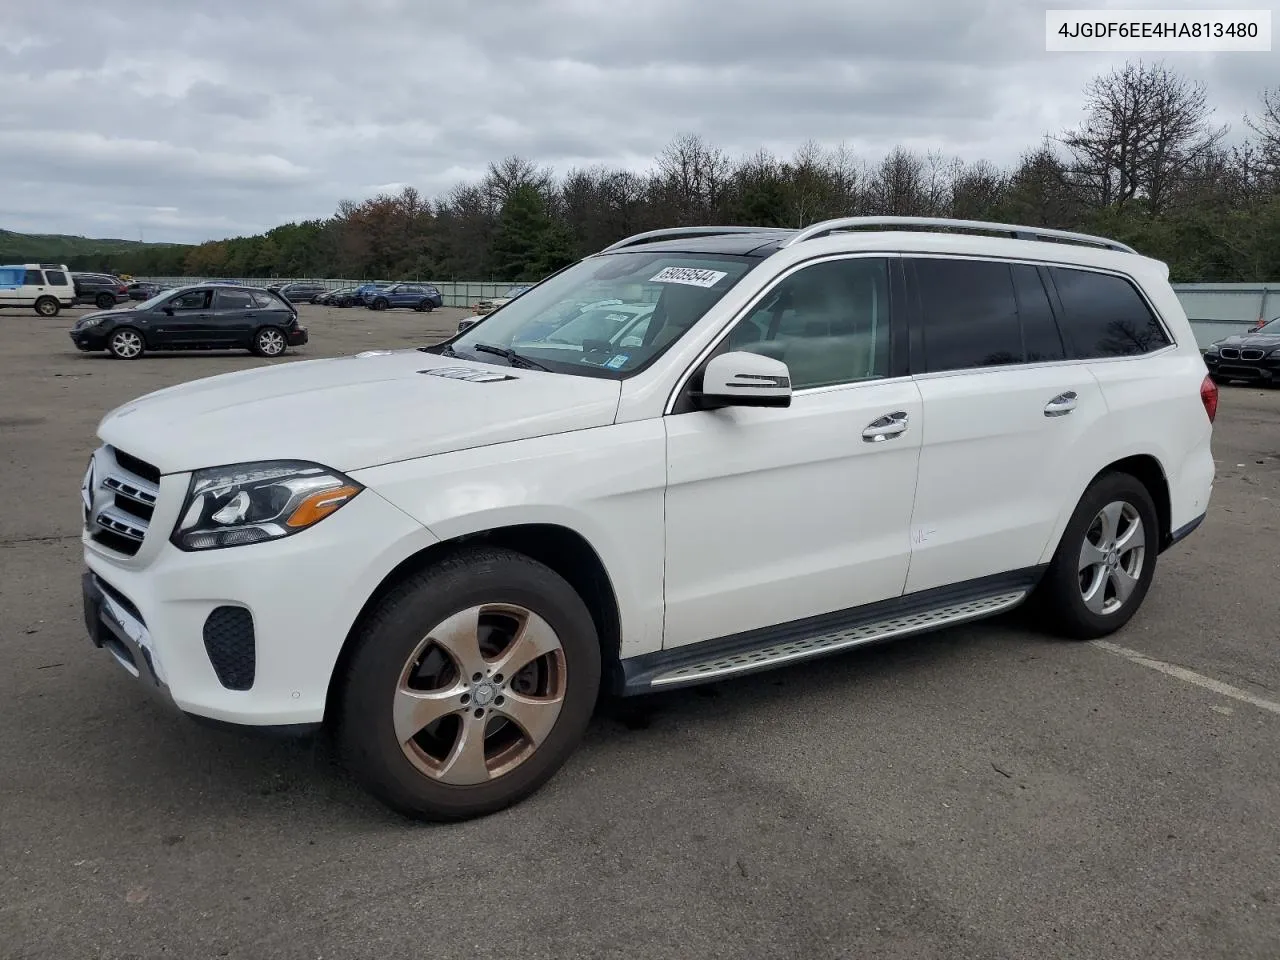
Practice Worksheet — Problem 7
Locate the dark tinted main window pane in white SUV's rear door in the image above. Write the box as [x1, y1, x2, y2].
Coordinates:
[914, 259, 1025, 372]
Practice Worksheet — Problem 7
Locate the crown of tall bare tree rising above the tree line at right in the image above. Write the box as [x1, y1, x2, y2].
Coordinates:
[1061, 63, 1228, 214]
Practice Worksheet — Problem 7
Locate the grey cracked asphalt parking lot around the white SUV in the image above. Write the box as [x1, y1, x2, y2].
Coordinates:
[0, 307, 1280, 960]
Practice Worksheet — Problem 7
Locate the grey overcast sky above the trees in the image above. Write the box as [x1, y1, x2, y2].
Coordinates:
[0, 0, 1280, 242]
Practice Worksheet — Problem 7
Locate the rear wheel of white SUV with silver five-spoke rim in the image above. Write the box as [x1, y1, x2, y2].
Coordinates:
[1038, 472, 1160, 640]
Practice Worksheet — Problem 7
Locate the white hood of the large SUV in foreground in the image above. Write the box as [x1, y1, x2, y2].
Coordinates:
[97, 349, 622, 474]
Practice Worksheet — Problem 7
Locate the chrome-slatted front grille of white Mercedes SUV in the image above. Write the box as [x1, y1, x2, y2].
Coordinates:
[81, 445, 160, 557]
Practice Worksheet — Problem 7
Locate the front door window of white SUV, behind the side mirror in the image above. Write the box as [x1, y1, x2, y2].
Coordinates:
[727, 257, 890, 390]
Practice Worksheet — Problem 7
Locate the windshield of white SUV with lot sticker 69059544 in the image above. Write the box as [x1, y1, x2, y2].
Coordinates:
[445, 251, 760, 379]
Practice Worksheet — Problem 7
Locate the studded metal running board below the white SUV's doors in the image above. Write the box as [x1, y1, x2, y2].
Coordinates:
[618, 567, 1043, 695]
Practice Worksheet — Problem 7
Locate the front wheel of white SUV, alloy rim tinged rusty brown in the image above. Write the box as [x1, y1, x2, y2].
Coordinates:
[337, 548, 600, 820]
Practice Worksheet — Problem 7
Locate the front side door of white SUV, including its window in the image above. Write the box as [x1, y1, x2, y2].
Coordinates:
[663, 257, 922, 648]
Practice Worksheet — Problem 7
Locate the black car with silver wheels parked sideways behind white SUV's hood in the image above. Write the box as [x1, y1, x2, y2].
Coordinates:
[70, 283, 308, 360]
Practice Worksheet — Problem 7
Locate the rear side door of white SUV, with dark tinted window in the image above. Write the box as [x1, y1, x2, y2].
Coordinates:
[905, 256, 1107, 593]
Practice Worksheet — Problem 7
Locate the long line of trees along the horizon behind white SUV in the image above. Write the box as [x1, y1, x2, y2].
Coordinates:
[64, 63, 1280, 282]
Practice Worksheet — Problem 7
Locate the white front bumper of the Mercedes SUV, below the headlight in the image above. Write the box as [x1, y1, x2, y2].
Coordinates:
[82, 475, 436, 728]
